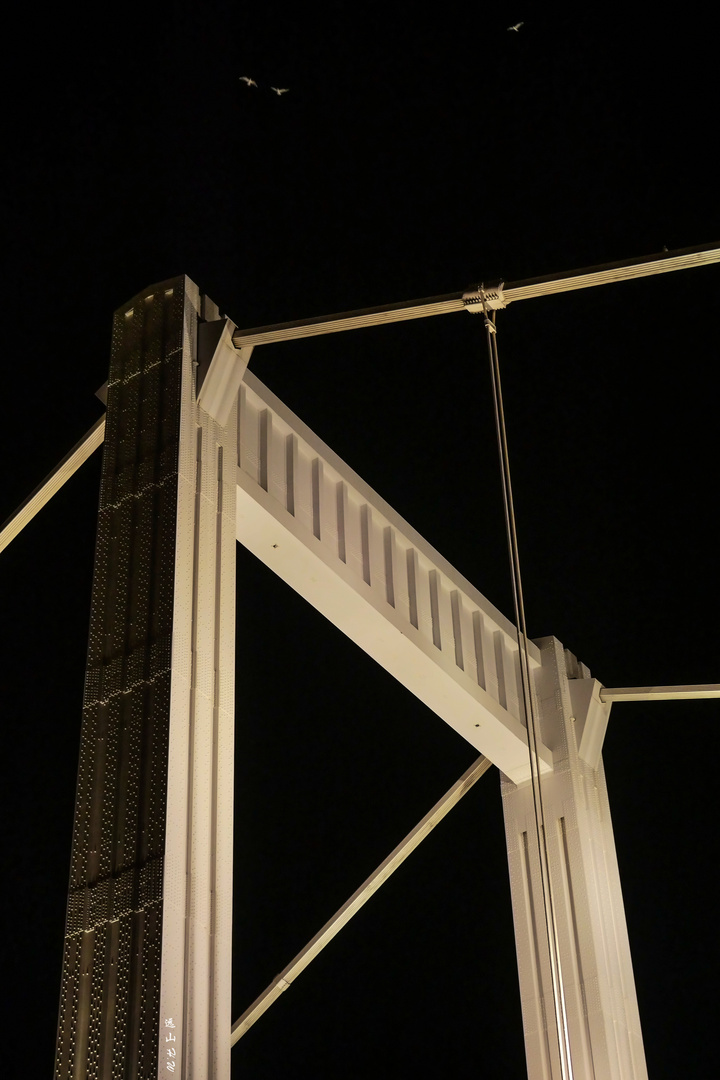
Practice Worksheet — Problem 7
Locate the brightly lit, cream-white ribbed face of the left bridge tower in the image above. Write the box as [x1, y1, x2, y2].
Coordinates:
[159, 279, 237, 1080]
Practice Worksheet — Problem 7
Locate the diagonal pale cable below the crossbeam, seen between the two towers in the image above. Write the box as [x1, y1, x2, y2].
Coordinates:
[230, 757, 491, 1045]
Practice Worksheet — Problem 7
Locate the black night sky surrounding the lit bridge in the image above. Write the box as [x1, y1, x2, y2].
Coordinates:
[0, 0, 720, 1080]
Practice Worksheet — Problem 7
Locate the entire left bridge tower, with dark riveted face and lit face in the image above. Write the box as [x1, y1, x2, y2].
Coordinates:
[55, 276, 242, 1080]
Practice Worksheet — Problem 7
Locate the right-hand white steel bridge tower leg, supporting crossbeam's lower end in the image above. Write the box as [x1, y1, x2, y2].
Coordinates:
[502, 637, 648, 1080]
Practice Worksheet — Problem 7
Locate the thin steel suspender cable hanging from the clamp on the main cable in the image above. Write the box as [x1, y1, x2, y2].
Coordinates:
[480, 289, 573, 1080]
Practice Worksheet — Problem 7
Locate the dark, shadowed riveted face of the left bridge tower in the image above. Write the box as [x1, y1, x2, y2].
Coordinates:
[56, 278, 185, 1080]
